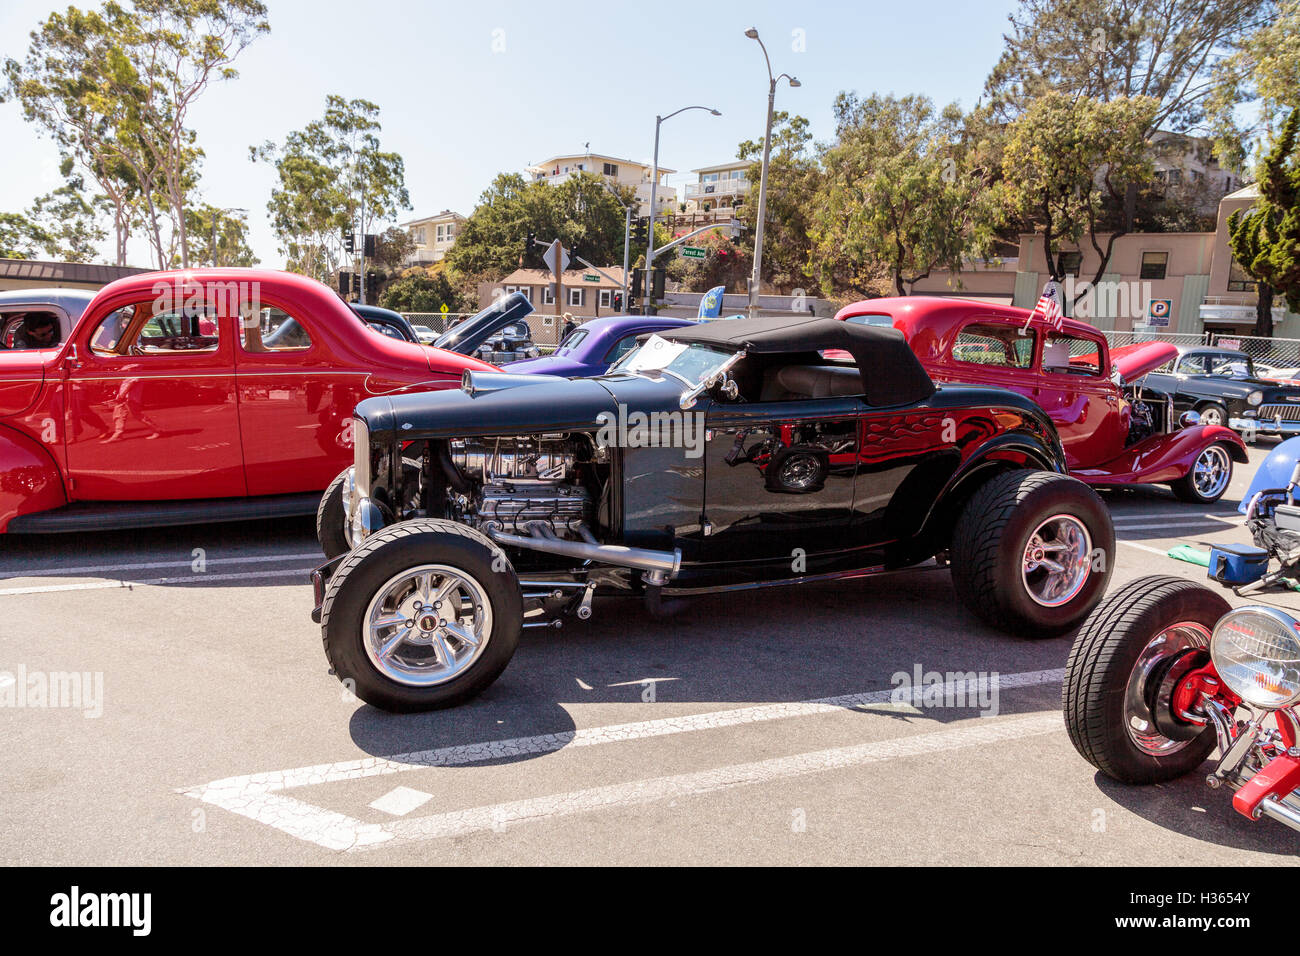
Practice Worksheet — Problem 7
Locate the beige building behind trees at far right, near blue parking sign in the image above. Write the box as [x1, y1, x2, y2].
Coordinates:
[915, 186, 1300, 338]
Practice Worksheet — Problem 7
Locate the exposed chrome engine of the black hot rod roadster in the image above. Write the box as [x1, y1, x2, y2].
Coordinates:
[450, 434, 595, 540]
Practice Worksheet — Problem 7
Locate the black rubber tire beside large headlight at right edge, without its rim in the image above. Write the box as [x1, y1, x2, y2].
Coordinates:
[1061, 575, 1230, 783]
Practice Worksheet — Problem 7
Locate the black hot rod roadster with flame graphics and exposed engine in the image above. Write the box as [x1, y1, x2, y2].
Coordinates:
[313, 319, 1114, 710]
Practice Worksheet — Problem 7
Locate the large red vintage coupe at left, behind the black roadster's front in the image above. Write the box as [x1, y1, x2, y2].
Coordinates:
[0, 269, 532, 546]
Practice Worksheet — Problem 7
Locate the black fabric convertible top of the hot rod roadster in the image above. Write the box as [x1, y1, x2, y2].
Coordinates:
[658, 316, 935, 406]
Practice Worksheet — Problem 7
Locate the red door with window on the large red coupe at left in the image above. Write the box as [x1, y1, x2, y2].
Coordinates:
[65, 299, 246, 501]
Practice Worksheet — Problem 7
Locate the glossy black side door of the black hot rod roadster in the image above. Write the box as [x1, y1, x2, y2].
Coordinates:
[702, 398, 865, 574]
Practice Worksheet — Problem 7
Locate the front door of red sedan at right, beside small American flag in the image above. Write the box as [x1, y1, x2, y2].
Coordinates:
[1037, 330, 1127, 468]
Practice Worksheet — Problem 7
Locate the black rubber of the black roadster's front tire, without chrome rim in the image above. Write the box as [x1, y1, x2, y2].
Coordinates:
[321, 518, 524, 713]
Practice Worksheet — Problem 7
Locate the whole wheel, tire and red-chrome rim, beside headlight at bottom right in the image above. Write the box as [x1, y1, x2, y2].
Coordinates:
[1061, 575, 1230, 783]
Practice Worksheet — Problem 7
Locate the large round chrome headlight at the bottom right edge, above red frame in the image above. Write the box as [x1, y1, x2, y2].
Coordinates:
[1210, 607, 1300, 710]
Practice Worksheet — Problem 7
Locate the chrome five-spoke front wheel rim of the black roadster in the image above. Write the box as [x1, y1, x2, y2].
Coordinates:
[364, 564, 491, 687]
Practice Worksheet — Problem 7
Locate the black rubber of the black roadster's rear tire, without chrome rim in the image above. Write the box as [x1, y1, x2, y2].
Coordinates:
[952, 471, 1115, 637]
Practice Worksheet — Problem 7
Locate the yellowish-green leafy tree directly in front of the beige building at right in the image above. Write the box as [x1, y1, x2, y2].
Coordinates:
[1000, 92, 1160, 300]
